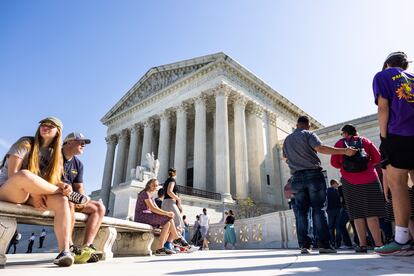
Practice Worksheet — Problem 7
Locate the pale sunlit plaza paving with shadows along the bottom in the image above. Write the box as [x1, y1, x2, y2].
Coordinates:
[0, 249, 414, 276]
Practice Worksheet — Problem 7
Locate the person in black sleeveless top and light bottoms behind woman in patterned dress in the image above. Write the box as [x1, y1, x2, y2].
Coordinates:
[162, 168, 184, 234]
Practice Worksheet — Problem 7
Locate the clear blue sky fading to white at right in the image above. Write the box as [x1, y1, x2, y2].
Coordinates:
[0, 0, 414, 192]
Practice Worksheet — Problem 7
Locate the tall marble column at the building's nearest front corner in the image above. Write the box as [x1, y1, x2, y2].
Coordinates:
[214, 85, 232, 201]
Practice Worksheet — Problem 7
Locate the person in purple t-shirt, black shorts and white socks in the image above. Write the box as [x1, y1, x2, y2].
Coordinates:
[373, 52, 414, 255]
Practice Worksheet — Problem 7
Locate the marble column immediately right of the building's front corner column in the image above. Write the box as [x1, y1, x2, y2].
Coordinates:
[233, 96, 249, 199]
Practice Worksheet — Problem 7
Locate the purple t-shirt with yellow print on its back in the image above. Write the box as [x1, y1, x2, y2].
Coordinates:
[372, 67, 414, 136]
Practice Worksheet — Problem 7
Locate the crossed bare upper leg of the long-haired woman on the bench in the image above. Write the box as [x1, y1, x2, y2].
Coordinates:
[0, 170, 59, 203]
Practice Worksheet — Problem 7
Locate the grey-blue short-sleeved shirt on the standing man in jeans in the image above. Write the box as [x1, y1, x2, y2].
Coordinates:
[283, 128, 322, 174]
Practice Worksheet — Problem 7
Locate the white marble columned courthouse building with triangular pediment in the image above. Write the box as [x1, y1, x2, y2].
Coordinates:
[99, 53, 322, 222]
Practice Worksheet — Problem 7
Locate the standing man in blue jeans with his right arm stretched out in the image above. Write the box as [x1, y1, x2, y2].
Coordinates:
[283, 116, 356, 254]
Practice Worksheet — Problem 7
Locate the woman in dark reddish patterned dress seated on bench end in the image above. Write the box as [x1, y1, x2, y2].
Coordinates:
[134, 178, 188, 255]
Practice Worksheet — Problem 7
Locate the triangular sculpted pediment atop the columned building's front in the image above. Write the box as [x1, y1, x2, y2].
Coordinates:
[102, 53, 225, 121]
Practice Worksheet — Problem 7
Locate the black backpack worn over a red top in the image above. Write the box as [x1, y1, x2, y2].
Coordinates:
[342, 137, 369, 172]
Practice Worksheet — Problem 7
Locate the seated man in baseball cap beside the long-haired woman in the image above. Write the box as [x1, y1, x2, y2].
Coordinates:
[62, 132, 105, 264]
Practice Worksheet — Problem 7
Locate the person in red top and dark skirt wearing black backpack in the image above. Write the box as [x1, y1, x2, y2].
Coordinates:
[331, 125, 385, 253]
